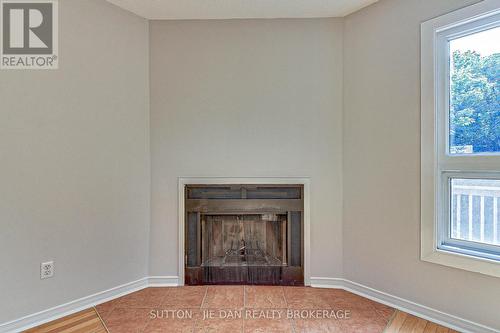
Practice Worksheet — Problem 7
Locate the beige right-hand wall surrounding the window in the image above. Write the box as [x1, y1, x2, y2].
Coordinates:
[343, 0, 500, 328]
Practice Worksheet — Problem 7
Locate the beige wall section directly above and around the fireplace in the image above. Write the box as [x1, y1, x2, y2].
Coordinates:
[150, 19, 342, 276]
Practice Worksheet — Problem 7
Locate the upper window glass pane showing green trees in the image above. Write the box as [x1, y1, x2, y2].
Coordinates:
[449, 27, 500, 155]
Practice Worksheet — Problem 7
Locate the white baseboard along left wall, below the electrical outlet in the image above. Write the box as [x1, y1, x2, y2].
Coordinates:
[0, 278, 148, 333]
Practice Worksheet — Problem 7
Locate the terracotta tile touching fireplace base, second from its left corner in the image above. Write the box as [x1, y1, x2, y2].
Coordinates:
[202, 286, 244, 309]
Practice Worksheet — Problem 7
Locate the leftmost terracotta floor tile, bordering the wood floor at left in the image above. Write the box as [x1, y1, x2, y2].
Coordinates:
[101, 308, 149, 333]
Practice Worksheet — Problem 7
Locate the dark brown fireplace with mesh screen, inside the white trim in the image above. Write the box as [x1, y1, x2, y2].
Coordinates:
[184, 184, 304, 285]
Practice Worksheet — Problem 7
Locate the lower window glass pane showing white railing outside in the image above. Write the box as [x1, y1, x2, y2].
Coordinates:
[450, 178, 500, 245]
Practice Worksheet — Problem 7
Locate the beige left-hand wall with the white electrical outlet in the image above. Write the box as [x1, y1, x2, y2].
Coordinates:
[0, 0, 150, 323]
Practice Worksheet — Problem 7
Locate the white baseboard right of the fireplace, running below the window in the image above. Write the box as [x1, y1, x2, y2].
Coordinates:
[311, 277, 500, 333]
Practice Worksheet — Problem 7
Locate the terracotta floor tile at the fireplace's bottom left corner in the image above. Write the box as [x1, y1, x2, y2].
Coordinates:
[162, 286, 207, 309]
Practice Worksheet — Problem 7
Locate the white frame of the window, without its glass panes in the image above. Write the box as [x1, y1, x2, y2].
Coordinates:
[421, 0, 500, 277]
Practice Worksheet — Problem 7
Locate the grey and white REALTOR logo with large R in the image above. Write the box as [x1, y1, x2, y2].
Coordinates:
[0, 0, 58, 69]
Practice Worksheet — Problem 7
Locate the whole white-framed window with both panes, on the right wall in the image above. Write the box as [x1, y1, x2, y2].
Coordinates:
[421, 0, 500, 277]
